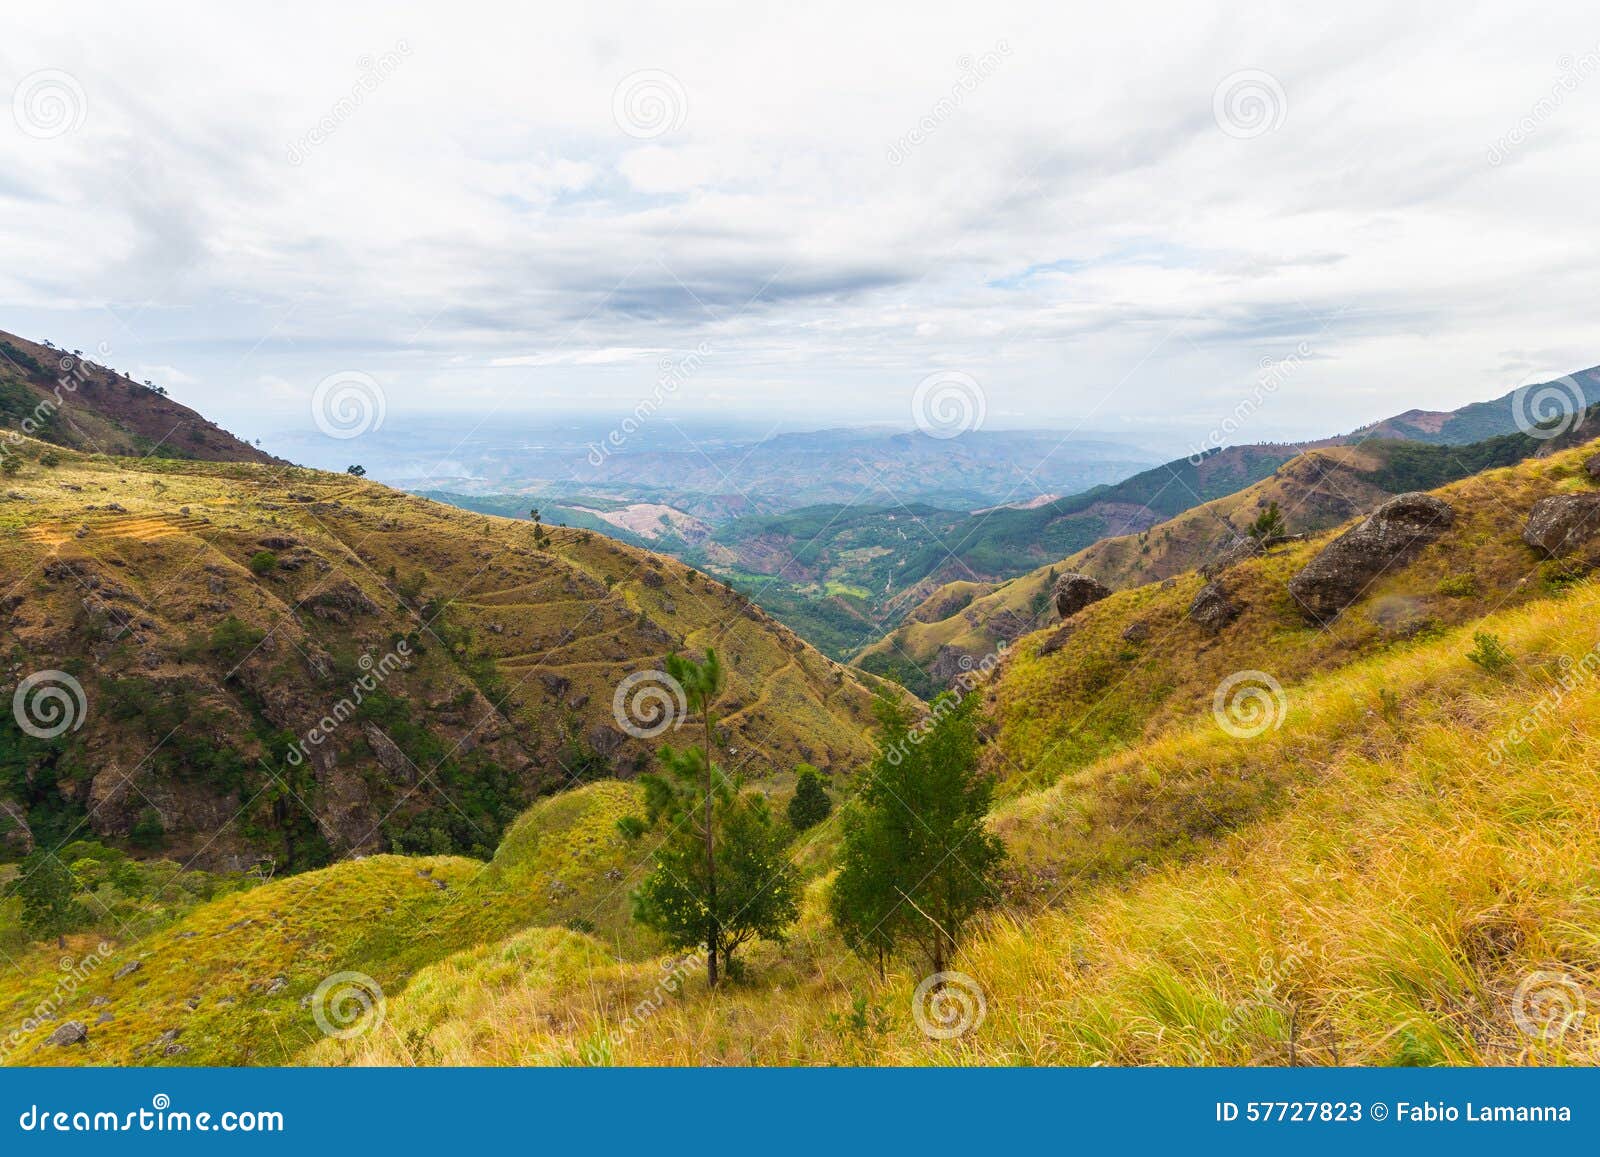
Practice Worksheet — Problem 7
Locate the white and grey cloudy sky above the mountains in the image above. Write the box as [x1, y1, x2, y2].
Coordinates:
[0, 0, 1600, 445]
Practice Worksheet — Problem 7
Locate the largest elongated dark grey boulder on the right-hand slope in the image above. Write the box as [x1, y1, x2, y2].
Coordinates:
[1290, 493, 1456, 621]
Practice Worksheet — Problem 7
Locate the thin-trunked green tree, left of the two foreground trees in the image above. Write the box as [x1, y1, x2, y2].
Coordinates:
[634, 747, 800, 984]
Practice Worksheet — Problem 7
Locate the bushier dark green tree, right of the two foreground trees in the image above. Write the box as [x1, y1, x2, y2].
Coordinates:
[829, 693, 1005, 973]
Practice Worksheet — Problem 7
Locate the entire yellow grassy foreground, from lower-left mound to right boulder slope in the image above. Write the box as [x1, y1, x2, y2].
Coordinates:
[9, 445, 1600, 1064]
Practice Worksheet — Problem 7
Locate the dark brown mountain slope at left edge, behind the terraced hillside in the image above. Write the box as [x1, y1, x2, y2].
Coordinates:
[0, 333, 277, 462]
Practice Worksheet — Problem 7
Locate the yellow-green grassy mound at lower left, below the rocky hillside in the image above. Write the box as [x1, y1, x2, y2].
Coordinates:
[0, 781, 654, 1064]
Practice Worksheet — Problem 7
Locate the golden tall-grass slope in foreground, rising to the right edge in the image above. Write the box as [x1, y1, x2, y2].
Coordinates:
[324, 576, 1600, 1064]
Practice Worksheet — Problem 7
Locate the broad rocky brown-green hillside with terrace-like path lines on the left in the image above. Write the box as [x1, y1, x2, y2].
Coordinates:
[0, 442, 872, 869]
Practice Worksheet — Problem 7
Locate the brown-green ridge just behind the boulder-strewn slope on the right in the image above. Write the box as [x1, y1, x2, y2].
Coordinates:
[856, 428, 1574, 695]
